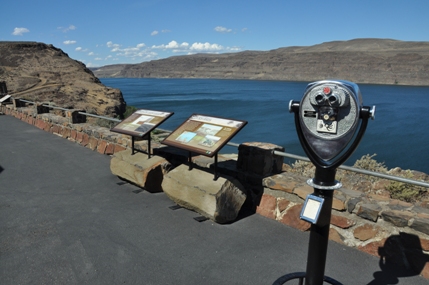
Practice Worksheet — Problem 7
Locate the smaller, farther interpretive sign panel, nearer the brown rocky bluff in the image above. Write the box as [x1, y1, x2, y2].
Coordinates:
[111, 109, 174, 137]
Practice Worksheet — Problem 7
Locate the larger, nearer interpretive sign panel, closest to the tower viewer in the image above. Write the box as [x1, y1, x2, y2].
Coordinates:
[162, 114, 247, 157]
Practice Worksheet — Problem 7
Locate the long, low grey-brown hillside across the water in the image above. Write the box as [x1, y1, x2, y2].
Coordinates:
[94, 39, 429, 85]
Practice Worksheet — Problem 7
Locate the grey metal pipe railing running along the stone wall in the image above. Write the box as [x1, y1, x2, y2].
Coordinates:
[10, 96, 429, 188]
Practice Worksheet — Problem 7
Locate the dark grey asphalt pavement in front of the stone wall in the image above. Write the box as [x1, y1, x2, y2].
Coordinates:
[0, 116, 429, 285]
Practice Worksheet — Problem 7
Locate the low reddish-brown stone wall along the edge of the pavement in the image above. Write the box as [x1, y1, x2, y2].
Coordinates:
[0, 104, 429, 278]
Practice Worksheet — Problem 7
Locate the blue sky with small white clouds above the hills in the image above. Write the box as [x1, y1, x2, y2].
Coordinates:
[0, 0, 429, 67]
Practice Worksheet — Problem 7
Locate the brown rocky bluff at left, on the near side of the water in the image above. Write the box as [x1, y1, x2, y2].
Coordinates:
[0, 42, 125, 115]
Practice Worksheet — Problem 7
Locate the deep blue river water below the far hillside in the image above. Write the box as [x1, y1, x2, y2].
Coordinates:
[100, 78, 429, 173]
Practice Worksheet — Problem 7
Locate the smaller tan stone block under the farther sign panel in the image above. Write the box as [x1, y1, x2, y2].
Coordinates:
[110, 150, 170, 193]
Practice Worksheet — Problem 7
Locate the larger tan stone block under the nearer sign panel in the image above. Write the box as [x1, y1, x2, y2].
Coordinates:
[162, 165, 246, 224]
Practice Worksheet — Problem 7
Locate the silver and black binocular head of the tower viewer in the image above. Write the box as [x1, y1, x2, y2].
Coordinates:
[289, 80, 375, 167]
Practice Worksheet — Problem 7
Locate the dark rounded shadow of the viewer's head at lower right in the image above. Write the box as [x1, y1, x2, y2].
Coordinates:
[368, 233, 429, 285]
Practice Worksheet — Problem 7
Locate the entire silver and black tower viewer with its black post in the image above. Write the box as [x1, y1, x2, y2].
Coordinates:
[274, 80, 375, 285]
